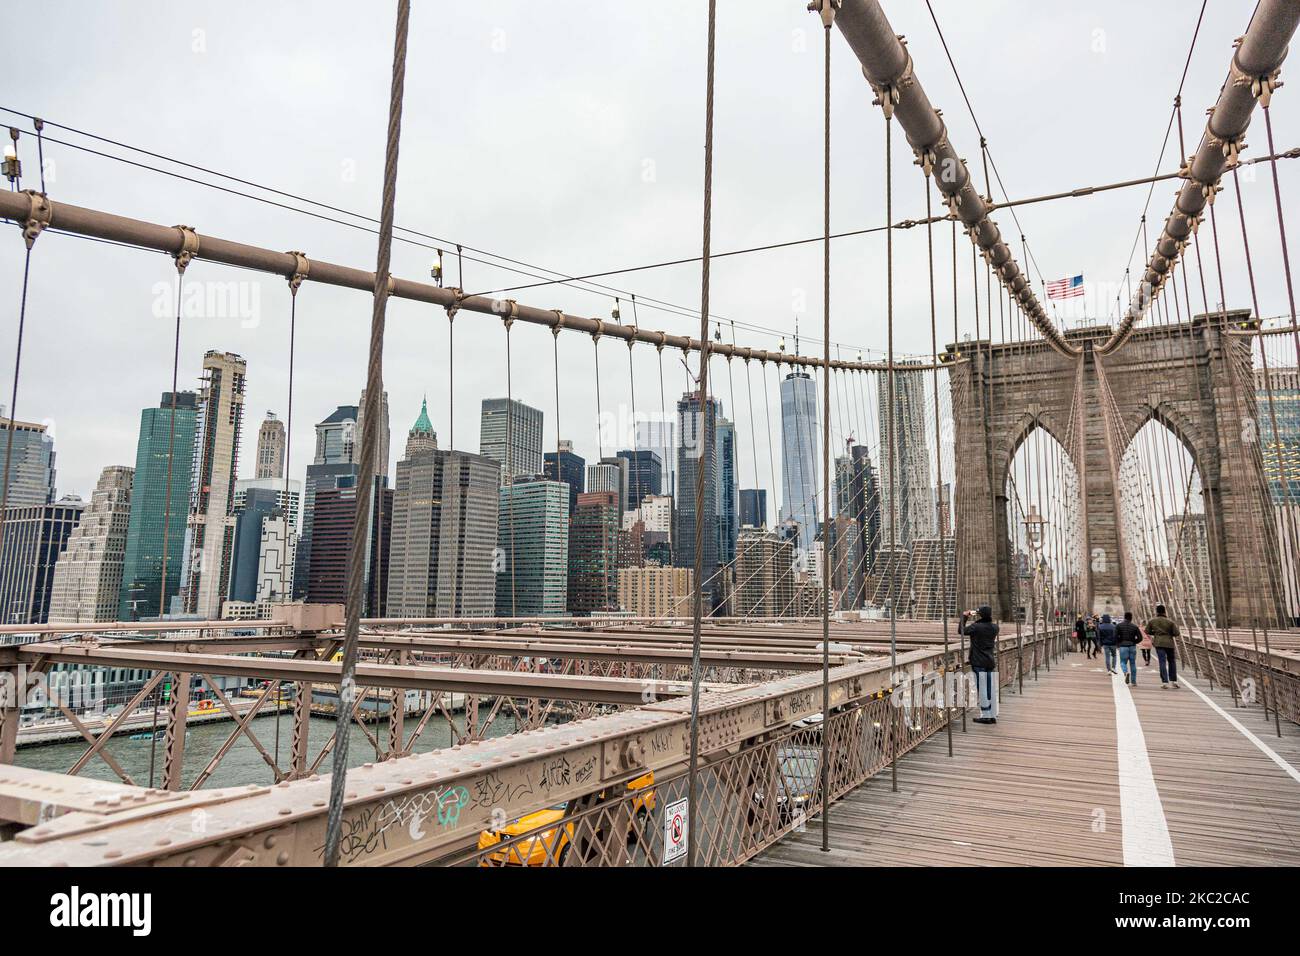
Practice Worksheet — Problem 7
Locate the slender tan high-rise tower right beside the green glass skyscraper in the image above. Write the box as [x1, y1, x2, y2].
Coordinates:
[179, 350, 247, 620]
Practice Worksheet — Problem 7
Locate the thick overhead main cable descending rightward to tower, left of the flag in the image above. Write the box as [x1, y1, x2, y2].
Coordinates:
[835, 0, 1079, 355]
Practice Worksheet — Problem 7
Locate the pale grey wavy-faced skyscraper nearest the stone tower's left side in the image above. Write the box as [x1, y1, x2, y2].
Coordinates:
[878, 371, 937, 548]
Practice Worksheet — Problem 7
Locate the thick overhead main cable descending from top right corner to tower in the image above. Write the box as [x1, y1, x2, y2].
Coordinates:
[1097, 0, 1300, 355]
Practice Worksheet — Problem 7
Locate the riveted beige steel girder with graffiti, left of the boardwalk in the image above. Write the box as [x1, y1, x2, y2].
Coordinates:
[0, 628, 1024, 866]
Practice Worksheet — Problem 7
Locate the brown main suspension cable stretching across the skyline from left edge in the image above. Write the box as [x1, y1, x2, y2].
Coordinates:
[0, 190, 933, 372]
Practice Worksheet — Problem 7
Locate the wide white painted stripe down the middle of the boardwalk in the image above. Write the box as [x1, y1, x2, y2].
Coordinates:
[1110, 676, 1174, 866]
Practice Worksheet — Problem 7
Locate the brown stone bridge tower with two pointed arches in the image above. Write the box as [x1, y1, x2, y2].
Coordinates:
[946, 311, 1282, 626]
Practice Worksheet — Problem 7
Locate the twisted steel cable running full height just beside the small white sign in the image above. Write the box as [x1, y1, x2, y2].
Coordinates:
[686, 0, 718, 866]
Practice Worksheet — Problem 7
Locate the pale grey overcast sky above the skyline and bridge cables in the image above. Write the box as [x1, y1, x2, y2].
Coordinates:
[0, 0, 1300, 509]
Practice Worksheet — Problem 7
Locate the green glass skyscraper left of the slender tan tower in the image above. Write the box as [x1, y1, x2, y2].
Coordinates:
[117, 392, 198, 620]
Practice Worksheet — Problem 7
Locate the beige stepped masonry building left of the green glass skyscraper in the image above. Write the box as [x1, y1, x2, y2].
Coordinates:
[49, 464, 134, 624]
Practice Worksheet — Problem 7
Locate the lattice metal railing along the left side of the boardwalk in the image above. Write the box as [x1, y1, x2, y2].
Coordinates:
[436, 628, 1069, 866]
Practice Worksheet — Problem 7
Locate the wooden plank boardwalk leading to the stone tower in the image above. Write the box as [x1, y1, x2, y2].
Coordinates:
[751, 653, 1300, 866]
